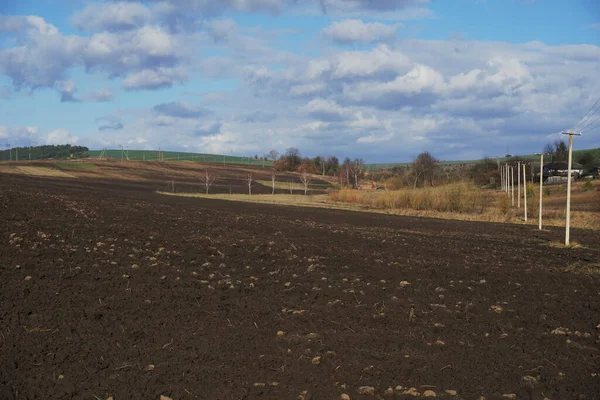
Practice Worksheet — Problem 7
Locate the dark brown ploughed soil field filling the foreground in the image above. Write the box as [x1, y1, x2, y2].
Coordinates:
[0, 174, 600, 400]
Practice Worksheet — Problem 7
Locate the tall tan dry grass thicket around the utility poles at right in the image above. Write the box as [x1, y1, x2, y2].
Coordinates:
[331, 182, 600, 229]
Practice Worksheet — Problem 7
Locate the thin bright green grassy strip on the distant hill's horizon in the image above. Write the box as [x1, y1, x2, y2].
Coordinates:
[89, 150, 273, 166]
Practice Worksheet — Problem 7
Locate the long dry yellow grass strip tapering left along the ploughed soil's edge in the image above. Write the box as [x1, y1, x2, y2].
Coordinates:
[160, 180, 600, 229]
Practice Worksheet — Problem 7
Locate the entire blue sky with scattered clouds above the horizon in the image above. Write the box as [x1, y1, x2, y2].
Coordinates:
[0, 0, 600, 162]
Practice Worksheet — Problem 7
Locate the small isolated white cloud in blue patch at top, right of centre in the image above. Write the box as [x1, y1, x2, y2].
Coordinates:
[323, 19, 400, 44]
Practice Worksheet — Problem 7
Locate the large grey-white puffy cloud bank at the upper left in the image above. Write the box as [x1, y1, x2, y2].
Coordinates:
[0, 16, 188, 94]
